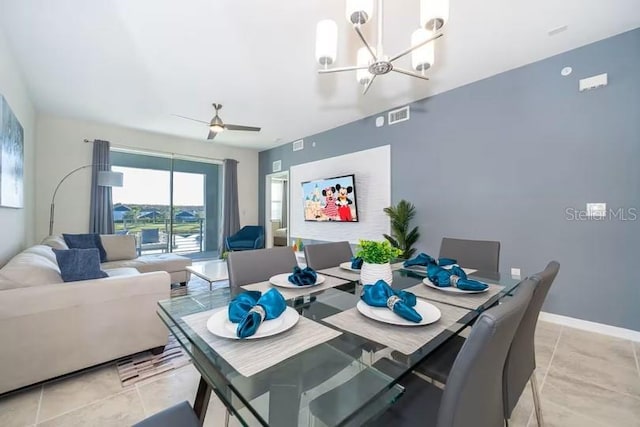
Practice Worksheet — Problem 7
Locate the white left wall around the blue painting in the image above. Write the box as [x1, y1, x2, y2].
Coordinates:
[0, 28, 36, 265]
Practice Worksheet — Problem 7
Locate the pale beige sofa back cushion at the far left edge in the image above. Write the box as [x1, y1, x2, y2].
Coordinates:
[0, 245, 63, 289]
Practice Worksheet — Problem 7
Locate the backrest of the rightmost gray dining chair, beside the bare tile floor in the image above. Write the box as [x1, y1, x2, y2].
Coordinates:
[503, 261, 560, 419]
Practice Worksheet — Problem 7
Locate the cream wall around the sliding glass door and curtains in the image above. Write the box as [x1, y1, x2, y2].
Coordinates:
[36, 115, 258, 239]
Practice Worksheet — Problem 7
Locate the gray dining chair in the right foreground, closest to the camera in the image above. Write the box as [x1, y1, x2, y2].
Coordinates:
[309, 280, 535, 427]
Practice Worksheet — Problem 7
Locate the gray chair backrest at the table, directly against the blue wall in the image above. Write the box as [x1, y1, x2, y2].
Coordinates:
[440, 237, 500, 272]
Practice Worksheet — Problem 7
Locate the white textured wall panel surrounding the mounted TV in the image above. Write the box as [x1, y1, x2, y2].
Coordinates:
[289, 145, 391, 243]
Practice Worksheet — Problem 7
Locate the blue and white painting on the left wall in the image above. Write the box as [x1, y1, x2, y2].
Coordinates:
[0, 95, 24, 208]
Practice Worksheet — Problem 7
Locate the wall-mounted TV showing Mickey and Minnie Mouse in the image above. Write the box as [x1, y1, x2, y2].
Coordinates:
[302, 175, 358, 222]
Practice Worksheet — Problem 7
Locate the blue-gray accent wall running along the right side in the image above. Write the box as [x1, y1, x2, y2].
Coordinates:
[259, 29, 640, 331]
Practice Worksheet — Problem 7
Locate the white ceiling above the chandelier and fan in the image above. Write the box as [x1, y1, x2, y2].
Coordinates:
[0, 0, 640, 149]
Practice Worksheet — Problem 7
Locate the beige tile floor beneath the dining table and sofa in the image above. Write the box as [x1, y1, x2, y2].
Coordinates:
[0, 272, 640, 427]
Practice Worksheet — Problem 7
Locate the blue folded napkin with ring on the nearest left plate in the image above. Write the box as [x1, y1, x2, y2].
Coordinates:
[229, 288, 287, 338]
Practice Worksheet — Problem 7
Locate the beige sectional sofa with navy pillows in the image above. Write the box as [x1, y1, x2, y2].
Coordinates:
[0, 239, 175, 394]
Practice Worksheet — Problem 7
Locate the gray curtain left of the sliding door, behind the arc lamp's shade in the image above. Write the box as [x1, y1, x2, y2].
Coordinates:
[89, 140, 114, 234]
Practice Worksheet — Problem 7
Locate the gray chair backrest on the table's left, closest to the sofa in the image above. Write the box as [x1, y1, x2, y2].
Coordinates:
[227, 246, 298, 294]
